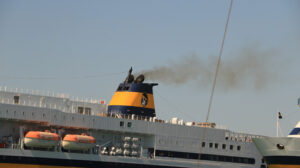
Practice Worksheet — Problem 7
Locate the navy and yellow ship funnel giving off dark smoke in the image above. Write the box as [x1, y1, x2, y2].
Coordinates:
[107, 68, 158, 117]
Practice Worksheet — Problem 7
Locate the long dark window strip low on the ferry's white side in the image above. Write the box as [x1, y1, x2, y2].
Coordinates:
[154, 149, 255, 164]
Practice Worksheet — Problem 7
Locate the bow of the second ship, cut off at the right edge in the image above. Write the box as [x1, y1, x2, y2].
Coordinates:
[253, 98, 300, 168]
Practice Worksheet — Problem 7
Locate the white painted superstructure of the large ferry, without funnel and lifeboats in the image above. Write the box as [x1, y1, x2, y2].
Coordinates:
[0, 91, 261, 168]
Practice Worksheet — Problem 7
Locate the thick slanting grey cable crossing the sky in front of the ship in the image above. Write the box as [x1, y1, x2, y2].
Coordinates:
[198, 0, 233, 167]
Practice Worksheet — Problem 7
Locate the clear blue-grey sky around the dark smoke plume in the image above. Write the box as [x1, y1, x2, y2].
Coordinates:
[0, 0, 300, 136]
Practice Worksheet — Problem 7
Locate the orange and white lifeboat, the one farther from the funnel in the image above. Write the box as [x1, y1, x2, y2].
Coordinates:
[24, 130, 60, 148]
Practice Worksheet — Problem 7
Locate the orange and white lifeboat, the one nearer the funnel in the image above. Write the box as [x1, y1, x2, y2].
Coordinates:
[62, 134, 96, 151]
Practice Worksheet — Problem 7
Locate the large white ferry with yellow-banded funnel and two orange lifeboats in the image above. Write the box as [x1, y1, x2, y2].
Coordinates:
[0, 69, 266, 168]
